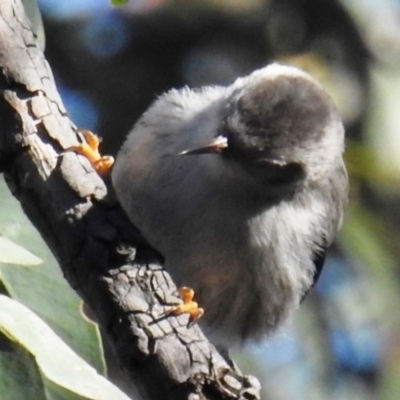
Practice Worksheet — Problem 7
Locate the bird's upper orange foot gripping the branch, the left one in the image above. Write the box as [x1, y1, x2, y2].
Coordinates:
[68, 129, 114, 175]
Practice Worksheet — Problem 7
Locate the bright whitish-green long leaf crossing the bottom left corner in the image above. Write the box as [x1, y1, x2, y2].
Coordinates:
[0, 295, 133, 400]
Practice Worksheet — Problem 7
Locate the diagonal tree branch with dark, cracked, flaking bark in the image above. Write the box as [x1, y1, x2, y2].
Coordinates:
[0, 0, 259, 400]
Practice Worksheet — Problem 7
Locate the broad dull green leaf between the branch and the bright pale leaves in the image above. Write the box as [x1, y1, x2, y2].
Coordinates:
[0, 175, 105, 376]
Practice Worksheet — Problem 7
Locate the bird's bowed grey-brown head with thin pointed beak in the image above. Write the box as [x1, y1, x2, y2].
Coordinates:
[183, 64, 344, 198]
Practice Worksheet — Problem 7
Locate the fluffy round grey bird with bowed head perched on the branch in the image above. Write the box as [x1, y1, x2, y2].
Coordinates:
[112, 64, 348, 348]
